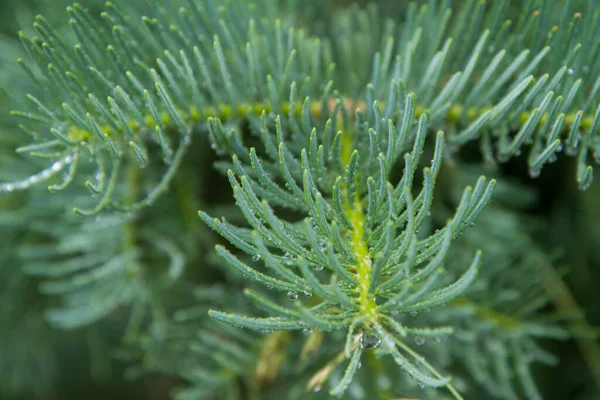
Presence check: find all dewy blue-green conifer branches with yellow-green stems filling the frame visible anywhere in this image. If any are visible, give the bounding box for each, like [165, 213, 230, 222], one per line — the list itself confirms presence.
[0, 0, 600, 399]
